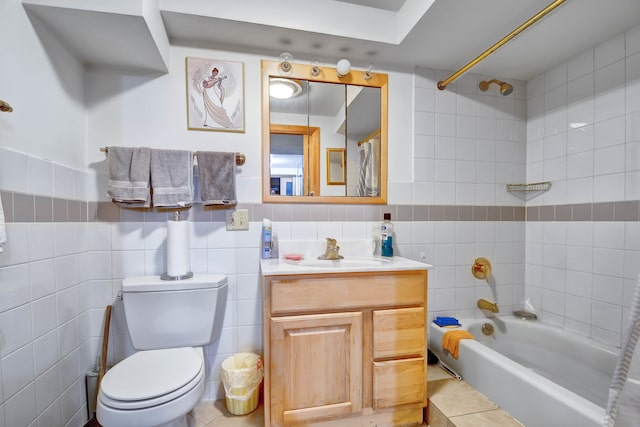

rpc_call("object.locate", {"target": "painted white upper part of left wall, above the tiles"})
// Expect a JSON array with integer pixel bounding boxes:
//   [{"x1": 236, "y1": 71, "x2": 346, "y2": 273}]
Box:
[{"x1": 0, "y1": 0, "x2": 86, "y2": 171}]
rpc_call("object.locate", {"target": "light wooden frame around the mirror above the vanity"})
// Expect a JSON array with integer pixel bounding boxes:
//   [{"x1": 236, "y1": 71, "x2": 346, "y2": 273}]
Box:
[{"x1": 261, "y1": 60, "x2": 389, "y2": 205}]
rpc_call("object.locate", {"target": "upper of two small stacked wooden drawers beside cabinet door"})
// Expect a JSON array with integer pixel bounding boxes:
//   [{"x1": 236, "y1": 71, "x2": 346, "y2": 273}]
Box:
[{"x1": 373, "y1": 307, "x2": 426, "y2": 359}]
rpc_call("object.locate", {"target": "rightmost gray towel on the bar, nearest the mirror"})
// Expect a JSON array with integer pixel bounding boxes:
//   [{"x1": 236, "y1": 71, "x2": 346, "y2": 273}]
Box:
[{"x1": 197, "y1": 151, "x2": 238, "y2": 206}]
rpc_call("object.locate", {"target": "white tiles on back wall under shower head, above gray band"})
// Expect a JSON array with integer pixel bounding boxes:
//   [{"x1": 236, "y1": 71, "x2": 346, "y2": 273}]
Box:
[{"x1": 416, "y1": 69, "x2": 527, "y2": 205}]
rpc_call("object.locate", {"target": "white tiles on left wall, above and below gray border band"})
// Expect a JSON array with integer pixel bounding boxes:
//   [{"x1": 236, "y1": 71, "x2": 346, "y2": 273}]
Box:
[{"x1": 0, "y1": 148, "x2": 102, "y2": 426}]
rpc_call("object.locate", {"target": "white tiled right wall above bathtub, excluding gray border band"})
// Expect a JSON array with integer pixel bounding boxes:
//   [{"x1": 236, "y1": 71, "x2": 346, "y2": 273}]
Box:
[{"x1": 526, "y1": 27, "x2": 640, "y2": 345}]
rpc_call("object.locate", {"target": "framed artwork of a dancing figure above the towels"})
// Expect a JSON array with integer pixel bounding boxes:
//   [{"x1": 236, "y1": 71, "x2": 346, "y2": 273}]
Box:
[{"x1": 186, "y1": 57, "x2": 244, "y2": 132}]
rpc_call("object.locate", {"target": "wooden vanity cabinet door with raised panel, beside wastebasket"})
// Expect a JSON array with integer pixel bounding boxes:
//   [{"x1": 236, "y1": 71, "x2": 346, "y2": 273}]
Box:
[{"x1": 270, "y1": 312, "x2": 362, "y2": 426}]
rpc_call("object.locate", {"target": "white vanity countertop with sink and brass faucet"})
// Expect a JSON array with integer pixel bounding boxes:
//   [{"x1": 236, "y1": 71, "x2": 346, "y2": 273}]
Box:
[{"x1": 260, "y1": 256, "x2": 433, "y2": 276}]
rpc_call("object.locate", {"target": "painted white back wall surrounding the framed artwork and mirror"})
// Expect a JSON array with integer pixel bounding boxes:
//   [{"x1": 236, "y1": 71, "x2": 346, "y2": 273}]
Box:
[{"x1": 86, "y1": 46, "x2": 413, "y2": 203}]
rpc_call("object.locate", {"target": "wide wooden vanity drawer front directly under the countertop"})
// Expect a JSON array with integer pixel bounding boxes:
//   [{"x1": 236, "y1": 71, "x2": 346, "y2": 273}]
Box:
[{"x1": 269, "y1": 271, "x2": 427, "y2": 314}]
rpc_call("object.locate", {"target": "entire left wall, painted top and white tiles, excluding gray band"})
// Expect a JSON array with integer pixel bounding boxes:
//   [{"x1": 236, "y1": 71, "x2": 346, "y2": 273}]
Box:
[{"x1": 0, "y1": 0, "x2": 93, "y2": 427}]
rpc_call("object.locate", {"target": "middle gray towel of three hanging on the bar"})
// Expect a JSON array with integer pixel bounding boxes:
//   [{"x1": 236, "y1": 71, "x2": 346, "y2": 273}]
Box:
[{"x1": 151, "y1": 149, "x2": 193, "y2": 207}]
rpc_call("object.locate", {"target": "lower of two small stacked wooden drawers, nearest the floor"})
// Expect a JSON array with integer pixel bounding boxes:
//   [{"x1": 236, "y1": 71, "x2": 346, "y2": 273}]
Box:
[{"x1": 373, "y1": 357, "x2": 427, "y2": 409}]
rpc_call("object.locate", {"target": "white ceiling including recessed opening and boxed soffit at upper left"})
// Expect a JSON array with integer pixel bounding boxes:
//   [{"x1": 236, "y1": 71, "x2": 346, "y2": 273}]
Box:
[{"x1": 23, "y1": 0, "x2": 640, "y2": 80}]
